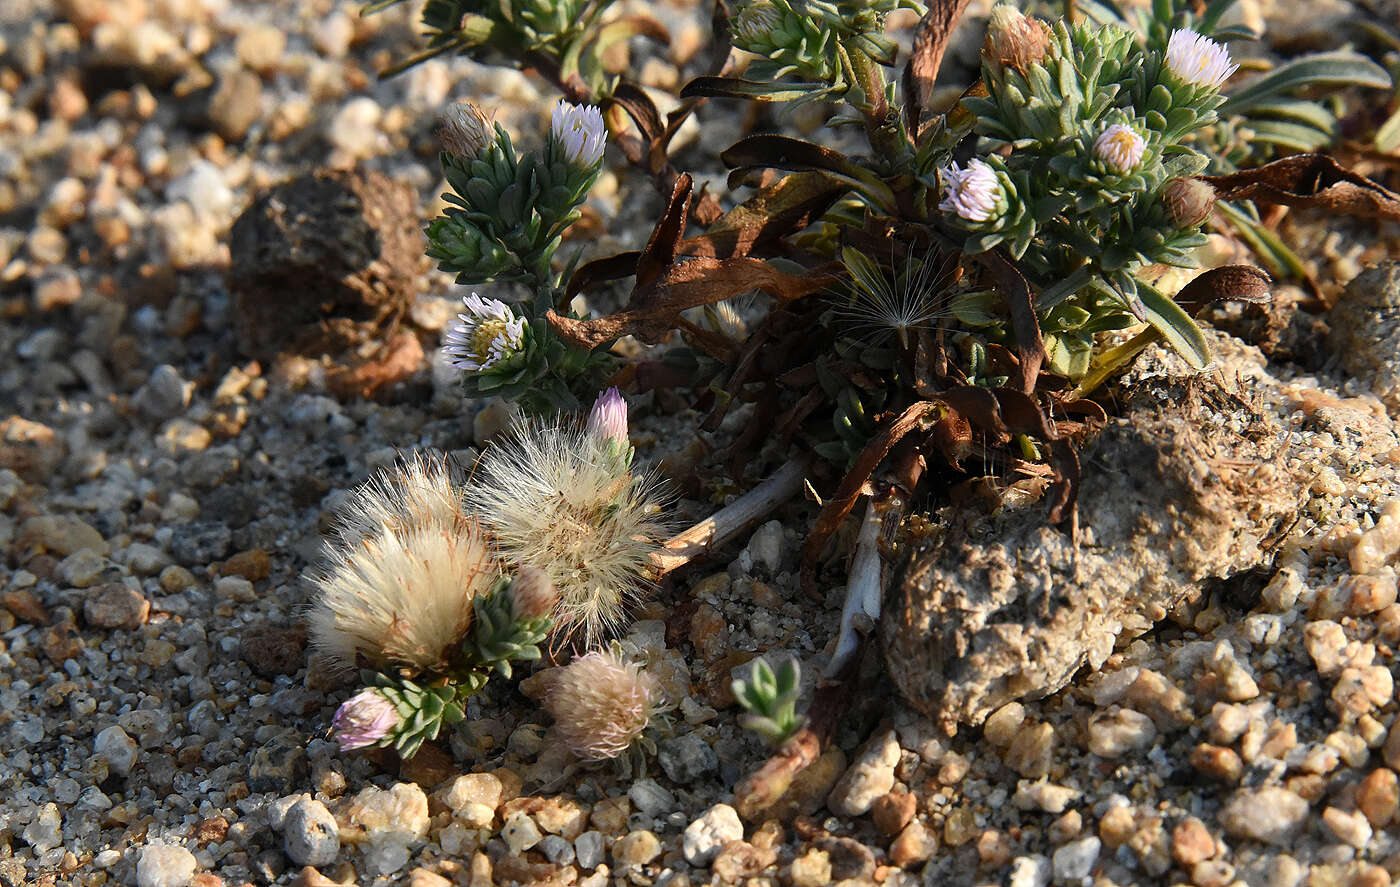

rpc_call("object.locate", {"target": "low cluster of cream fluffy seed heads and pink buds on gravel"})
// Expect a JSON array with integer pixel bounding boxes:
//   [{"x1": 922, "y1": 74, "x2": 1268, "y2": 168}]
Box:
[{"x1": 317, "y1": 388, "x2": 661, "y2": 757}]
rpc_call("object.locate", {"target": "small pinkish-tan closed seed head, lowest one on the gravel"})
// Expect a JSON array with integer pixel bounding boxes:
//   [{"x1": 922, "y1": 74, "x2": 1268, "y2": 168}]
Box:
[{"x1": 545, "y1": 651, "x2": 661, "y2": 761}]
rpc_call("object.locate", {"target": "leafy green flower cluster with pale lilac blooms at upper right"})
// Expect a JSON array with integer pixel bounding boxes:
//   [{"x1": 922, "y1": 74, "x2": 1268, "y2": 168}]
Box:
[{"x1": 946, "y1": 6, "x2": 1236, "y2": 378}]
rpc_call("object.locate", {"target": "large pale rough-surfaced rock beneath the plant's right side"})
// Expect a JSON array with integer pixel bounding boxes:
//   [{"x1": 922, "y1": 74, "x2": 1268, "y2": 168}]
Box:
[{"x1": 883, "y1": 334, "x2": 1306, "y2": 733}]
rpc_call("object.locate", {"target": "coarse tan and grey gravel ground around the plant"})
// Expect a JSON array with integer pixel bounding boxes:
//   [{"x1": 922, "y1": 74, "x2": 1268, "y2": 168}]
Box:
[{"x1": 0, "y1": 0, "x2": 1400, "y2": 887}]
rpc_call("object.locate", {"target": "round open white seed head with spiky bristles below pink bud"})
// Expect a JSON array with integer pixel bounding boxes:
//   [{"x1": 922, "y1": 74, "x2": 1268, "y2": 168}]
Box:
[{"x1": 466, "y1": 423, "x2": 666, "y2": 645}]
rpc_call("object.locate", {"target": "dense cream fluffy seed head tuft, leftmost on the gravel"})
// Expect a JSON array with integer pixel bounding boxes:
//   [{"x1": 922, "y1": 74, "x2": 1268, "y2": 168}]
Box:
[{"x1": 307, "y1": 456, "x2": 498, "y2": 669}]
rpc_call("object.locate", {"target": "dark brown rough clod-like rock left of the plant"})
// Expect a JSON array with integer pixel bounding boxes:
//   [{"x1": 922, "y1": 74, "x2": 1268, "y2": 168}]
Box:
[{"x1": 228, "y1": 171, "x2": 427, "y2": 360}]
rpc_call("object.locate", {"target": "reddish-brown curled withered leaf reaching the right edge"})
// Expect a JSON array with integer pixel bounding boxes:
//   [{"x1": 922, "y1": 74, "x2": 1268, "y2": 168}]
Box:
[{"x1": 1200, "y1": 154, "x2": 1400, "y2": 221}]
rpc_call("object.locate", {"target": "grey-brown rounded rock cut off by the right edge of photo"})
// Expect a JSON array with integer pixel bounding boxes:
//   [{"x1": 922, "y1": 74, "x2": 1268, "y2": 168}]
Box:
[{"x1": 1327, "y1": 262, "x2": 1400, "y2": 416}]
